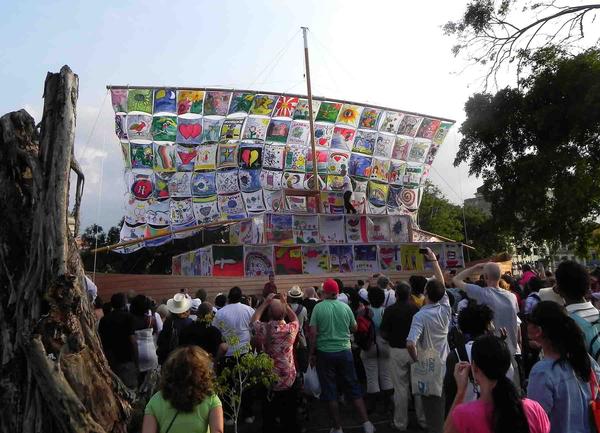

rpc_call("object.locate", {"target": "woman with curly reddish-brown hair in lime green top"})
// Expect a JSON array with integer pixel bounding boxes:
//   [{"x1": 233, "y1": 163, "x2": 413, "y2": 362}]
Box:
[{"x1": 142, "y1": 346, "x2": 223, "y2": 433}]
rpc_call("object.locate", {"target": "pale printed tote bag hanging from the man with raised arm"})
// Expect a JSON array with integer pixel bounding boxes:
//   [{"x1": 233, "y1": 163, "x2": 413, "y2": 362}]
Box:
[{"x1": 410, "y1": 335, "x2": 446, "y2": 397}]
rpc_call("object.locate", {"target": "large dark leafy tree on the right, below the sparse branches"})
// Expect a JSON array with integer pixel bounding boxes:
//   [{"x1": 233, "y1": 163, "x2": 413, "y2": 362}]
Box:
[{"x1": 454, "y1": 48, "x2": 600, "y2": 254}]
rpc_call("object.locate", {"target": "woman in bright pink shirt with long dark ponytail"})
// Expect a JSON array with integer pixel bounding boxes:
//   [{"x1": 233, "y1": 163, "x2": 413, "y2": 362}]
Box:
[{"x1": 444, "y1": 335, "x2": 550, "y2": 433}]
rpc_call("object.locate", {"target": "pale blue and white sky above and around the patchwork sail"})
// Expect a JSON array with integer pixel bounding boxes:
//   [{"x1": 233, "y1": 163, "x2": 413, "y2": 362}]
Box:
[{"x1": 0, "y1": 0, "x2": 482, "y2": 229}]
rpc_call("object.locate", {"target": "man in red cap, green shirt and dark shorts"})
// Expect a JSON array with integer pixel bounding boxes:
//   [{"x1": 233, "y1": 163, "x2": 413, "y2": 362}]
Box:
[{"x1": 310, "y1": 278, "x2": 375, "y2": 433}]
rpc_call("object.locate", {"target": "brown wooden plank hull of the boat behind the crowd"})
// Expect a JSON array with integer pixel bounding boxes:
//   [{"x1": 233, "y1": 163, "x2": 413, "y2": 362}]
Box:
[{"x1": 89, "y1": 271, "x2": 431, "y2": 302}]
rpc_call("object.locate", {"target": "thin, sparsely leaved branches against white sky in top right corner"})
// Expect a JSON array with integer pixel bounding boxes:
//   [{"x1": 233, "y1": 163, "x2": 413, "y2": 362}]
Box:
[{"x1": 444, "y1": 0, "x2": 600, "y2": 88}]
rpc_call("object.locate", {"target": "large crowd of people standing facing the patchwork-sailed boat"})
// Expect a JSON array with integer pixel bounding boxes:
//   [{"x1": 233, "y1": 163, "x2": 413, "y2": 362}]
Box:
[{"x1": 95, "y1": 249, "x2": 600, "y2": 433}]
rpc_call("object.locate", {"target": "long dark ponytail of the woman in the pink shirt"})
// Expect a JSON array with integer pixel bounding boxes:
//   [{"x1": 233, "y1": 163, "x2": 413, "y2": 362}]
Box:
[{"x1": 492, "y1": 376, "x2": 529, "y2": 433}]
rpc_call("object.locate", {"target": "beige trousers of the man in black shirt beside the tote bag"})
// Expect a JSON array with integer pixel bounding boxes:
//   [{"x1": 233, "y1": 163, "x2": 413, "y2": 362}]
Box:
[{"x1": 390, "y1": 347, "x2": 427, "y2": 430}]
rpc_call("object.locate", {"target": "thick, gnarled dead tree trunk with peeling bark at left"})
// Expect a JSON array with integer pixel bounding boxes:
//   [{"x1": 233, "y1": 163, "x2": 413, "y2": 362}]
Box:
[{"x1": 0, "y1": 66, "x2": 131, "y2": 433}]
